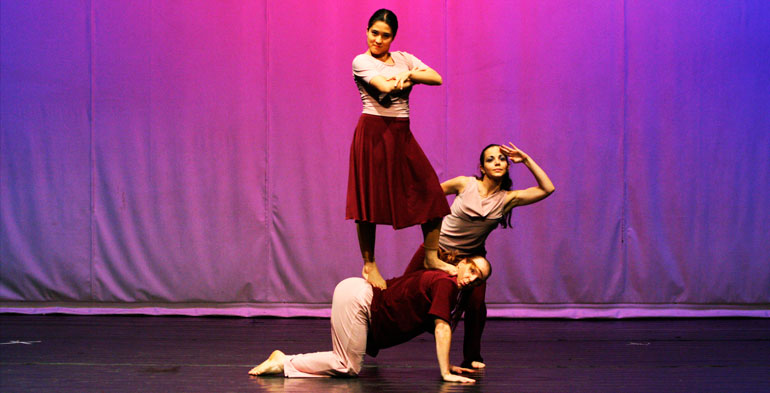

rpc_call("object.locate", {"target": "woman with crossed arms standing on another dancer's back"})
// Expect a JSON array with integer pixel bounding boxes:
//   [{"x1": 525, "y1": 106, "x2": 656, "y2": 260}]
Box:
[{"x1": 345, "y1": 9, "x2": 448, "y2": 289}]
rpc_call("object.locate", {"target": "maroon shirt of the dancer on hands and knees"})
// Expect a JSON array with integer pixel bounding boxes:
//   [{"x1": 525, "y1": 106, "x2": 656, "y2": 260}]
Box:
[{"x1": 366, "y1": 270, "x2": 459, "y2": 356}]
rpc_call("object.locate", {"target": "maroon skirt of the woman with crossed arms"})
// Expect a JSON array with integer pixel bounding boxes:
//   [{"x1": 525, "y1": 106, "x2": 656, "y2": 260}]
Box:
[{"x1": 345, "y1": 114, "x2": 449, "y2": 229}]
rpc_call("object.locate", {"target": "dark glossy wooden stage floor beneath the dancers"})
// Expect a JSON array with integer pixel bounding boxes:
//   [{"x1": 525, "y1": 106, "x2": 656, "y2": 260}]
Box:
[{"x1": 0, "y1": 314, "x2": 770, "y2": 392}]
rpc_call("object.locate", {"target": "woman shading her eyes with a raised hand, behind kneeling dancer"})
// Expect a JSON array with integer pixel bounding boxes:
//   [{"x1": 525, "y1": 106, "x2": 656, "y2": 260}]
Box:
[{"x1": 404, "y1": 143, "x2": 555, "y2": 368}]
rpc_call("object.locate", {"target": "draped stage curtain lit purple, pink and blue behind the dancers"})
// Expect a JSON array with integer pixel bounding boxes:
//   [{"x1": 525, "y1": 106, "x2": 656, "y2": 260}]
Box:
[{"x1": 0, "y1": 0, "x2": 770, "y2": 317}]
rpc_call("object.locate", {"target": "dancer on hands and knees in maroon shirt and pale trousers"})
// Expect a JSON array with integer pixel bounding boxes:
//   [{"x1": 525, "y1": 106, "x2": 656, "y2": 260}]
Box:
[{"x1": 249, "y1": 256, "x2": 492, "y2": 383}]
